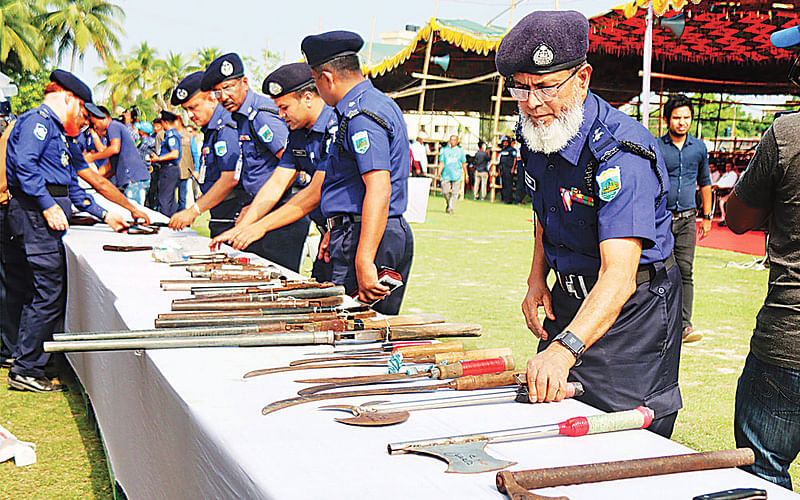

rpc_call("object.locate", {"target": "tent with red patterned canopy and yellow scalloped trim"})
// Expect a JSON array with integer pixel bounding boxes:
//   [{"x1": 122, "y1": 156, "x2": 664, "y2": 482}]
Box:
[{"x1": 367, "y1": 0, "x2": 800, "y2": 114}]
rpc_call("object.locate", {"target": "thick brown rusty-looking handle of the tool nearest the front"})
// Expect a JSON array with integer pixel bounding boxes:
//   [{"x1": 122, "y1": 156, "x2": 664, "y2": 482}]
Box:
[{"x1": 497, "y1": 448, "x2": 755, "y2": 493}]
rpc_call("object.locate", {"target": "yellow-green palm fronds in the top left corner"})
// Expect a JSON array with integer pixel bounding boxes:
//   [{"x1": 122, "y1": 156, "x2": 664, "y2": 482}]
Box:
[{"x1": 0, "y1": 0, "x2": 41, "y2": 72}]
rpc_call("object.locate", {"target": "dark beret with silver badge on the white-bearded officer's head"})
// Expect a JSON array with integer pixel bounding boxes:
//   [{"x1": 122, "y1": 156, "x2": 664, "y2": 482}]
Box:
[{"x1": 494, "y1": 10, "x2": 589, "y2": 77}]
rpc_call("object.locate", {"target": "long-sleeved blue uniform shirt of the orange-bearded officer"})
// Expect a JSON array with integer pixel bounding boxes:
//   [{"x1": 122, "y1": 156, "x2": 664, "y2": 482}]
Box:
[{"x1": 6, "y1": 104, "x2": 103, "y2": 217}]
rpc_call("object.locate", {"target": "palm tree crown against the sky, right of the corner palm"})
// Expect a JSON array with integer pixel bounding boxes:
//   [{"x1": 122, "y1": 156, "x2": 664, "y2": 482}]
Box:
[{"x1": 41, "y1": 0, "x2": 125, "y2": 71}]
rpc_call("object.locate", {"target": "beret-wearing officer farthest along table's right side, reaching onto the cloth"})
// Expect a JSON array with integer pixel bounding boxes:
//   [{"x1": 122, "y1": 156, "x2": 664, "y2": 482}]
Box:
[{"x1": 169, "y1": 71, "x2": 242, "y2": 238}]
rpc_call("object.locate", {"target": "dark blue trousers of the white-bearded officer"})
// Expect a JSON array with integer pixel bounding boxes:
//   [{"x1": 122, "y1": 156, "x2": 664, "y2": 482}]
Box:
[{"x1": 539, "y1": 262, "x2": 683, "y2": 438}]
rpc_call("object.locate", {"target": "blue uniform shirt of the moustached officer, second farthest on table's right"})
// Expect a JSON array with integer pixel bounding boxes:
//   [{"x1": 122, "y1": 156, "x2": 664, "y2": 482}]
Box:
[{"x1": 232, "y1": 90, "x2": 289, "y2": 196}]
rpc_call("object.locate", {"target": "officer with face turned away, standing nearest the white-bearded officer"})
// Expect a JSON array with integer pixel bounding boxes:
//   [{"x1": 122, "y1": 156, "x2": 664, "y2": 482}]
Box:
[{"x1": 216, "y1": 31, "x2": 414, "y2": 314}]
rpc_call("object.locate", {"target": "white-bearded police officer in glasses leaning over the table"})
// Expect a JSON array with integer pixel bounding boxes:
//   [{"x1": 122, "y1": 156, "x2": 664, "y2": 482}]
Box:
[{"x1": 496, "y1": 11, "x2": 682, "y2": 437}]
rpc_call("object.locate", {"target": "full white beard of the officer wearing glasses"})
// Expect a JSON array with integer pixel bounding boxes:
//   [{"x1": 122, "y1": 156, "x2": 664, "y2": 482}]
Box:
[{"x1": 519, "y1": 93, "x2": 583, "y2": 154}]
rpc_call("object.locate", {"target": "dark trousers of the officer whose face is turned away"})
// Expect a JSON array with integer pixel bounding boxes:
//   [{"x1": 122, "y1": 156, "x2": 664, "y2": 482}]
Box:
[{"x1": 330, "y1": 217, "x2": 414, "y2": 314}]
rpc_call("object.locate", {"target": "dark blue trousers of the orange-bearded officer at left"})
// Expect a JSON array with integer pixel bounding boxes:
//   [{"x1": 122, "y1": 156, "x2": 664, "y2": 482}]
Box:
[{"x1": 4, "y1": 196, "x2": 70, "y2": 377}]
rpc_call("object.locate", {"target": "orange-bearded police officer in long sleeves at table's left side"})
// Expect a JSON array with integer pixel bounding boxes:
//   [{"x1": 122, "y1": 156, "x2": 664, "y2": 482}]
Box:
[{"x1": 2, "y1": 70, "x2": 126, "y2": 392}]
